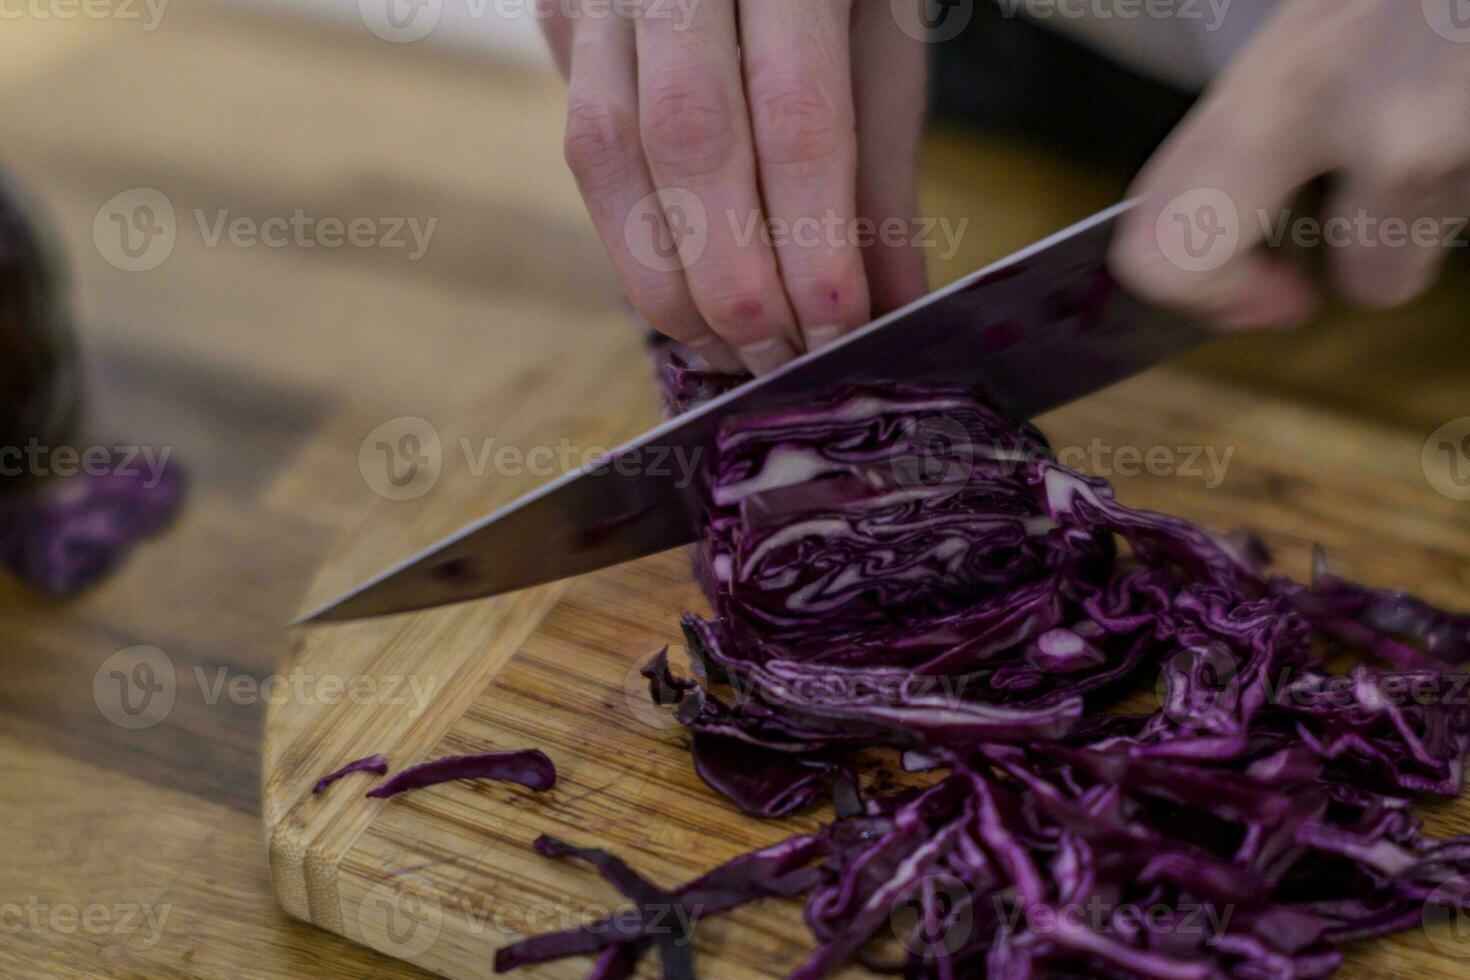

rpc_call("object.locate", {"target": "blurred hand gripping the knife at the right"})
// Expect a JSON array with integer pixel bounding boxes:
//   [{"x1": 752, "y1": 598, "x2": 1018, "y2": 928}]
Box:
[{"x1": 1111, "y1": 0, "x2": 1470, "y2": 329}]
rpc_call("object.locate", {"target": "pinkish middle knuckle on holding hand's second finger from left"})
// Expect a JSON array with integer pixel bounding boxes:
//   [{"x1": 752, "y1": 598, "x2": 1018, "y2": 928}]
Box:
[{"x1": 642, "y1": 68, "x2": 738, "y2": 176}]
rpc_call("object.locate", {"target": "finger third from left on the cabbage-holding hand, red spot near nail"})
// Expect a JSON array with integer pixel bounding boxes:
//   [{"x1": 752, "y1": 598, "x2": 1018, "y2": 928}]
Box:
[{"x1": 739, "y1": 0, "x2": 872, "y2": 350}]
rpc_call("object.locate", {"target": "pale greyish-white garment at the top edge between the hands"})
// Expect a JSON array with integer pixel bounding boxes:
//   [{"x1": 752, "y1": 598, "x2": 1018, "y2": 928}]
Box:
[{"x1": 995, "y1": 0, "x2": 1276, "y2": 90}]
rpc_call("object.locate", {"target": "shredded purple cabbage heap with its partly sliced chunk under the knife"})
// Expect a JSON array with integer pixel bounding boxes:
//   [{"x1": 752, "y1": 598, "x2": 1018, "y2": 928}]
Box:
[{"x1": 497, "y1": 354, "x2": 1470, "y2": 980}]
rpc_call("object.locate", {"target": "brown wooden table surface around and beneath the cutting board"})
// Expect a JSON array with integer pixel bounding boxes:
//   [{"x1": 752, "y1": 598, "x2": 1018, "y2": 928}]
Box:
[{"x1": 0, "y1": 3, "x2": 1470, "y2": 977}]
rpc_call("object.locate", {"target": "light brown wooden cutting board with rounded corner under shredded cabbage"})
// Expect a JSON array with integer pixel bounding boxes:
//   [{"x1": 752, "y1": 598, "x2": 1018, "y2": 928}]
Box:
[{"x1": 263, "y1": 354, "x2": 1470, "y2": 979}]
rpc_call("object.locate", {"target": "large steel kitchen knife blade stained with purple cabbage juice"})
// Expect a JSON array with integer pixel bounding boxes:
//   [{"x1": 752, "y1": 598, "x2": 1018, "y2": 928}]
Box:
[{"x1": 297, "y1": 201, "x2": 1210, "y2": 623}]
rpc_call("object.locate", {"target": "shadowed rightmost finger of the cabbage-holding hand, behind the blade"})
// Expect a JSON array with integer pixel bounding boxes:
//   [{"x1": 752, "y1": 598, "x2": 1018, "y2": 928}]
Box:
[{"x1": 853, "y1": 1, "x2": 929, "y2": 316}]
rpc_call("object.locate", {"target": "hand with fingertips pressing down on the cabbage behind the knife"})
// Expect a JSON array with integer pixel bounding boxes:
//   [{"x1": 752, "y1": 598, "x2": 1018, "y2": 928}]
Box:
[{"x1": 542, "y1": 0, "x2": 928, "y2": 373}]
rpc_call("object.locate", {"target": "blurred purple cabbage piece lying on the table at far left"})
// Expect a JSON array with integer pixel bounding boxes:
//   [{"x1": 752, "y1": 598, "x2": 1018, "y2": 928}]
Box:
[{"x1": 0, "y1": 463, "x2": 184, "y2": 595}]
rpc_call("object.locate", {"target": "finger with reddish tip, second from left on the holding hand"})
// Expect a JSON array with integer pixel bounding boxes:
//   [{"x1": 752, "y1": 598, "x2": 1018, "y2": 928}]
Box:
[{"x1": 638, "y1": 0, "x2": 797, "y2": 375}]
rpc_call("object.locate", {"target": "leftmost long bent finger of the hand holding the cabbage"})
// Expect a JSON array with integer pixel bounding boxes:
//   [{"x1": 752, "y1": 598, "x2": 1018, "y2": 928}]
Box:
[{"x1": 566, "y1": 18, "x2": 741, "y2": 372}]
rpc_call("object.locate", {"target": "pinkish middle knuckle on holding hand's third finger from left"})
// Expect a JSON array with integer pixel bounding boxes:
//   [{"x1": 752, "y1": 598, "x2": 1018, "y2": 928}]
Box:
[{"x1": 750, "y1": 71, "x2": 854, "y2": 175}]
